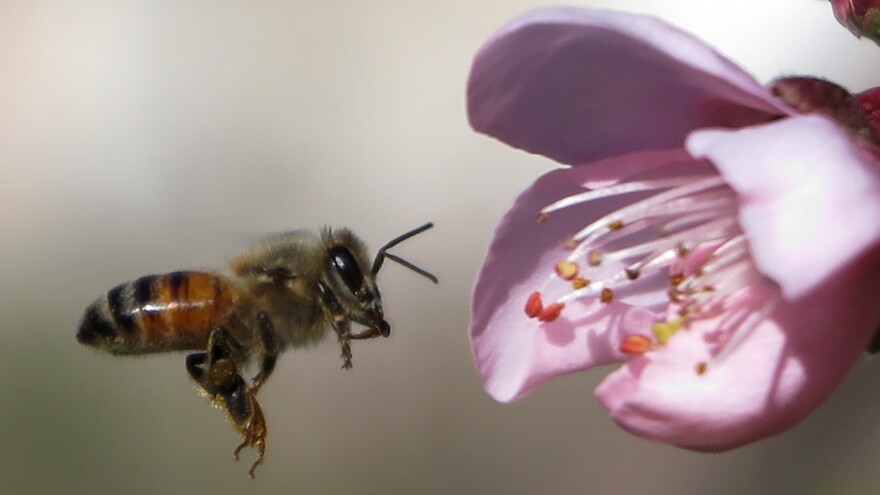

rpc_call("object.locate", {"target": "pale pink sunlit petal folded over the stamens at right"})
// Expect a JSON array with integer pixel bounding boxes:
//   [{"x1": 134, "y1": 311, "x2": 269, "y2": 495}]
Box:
[{"x1": 687, "y1": 116, "x2": 880, "y2": 299}]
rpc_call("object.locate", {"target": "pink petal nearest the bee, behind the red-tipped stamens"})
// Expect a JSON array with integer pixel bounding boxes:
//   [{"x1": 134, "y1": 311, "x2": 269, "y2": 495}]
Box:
[{"x1": 471, "y1": 167, "x2": 656, "y2": 402}]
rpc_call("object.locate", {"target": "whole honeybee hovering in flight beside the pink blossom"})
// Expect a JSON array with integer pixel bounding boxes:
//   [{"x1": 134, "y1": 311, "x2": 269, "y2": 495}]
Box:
[{"x1": 76, "y1": 223, "x2": 437, "y2": 478}]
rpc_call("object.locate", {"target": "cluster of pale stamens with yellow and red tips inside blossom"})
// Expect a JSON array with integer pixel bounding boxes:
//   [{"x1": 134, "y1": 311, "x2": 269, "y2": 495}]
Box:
[{"x1": 525, "y1": 171, "x2": 775, "y2": 374}]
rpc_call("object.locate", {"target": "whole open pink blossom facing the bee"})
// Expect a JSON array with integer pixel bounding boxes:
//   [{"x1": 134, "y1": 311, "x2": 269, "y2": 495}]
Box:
[{"x1": 468, "y1": 5, "x2": 880, "y2": 450}]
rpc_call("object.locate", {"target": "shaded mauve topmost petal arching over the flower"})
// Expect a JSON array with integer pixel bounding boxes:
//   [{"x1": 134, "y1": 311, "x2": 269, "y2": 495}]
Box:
[{"x1": 468, "y1": 8, "x2": 788, "y2": 164}]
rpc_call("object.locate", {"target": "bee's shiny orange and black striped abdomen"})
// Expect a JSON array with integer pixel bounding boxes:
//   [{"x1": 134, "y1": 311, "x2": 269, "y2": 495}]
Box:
[{"x1": 76, "y1": 271, "x2": 234, "y2": 354}]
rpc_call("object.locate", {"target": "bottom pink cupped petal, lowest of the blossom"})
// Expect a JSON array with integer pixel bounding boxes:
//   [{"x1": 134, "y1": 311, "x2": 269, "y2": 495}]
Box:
[{"x1": 595, "y1": 252, "x2": 880, "y2": 451}]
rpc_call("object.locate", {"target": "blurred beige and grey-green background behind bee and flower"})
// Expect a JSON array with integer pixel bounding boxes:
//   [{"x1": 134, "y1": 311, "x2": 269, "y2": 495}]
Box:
[{"x1": 0, "y1": 0, "x2": 880, "y2": 495}]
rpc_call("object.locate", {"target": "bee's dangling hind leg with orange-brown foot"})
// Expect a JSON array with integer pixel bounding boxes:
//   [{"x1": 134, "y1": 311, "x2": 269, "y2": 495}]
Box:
[{"x1": 186, "y1": 327, "x2": 267, "y2": 478}]
